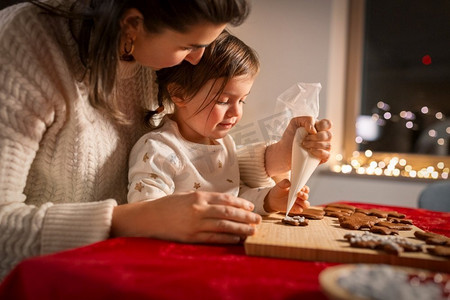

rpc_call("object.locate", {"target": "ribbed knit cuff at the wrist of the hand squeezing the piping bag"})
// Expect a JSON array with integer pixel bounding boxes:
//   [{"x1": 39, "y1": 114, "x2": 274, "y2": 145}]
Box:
[{"x1": 237, "y1": 143, "x2": 274, "y2": 188}]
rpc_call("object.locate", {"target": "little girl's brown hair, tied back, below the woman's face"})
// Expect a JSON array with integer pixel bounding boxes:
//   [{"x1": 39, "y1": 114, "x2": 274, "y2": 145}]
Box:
[{"x1": 146, "y1": 30, "x2": 259, "y2": 128}]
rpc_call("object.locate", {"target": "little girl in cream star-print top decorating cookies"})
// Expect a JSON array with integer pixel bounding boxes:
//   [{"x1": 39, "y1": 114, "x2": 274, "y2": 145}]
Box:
[{"x1": 128, "y1": 31, "x2": 308, "y2": 215}]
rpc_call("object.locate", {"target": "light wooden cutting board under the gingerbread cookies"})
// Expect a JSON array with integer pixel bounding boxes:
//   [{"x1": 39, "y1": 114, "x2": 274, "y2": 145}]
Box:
[{"x1": 244, "y1": 214, "x2": 450, "y2": 272}]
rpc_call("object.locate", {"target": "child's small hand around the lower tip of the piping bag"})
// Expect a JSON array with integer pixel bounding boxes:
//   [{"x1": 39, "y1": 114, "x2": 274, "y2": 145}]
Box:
[{"x1": 264, "y1": 179, "x2": 310, "y2": 213}]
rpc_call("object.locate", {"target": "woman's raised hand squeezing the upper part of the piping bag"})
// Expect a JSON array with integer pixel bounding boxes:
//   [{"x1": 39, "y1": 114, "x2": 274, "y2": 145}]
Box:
[{"x1": 265, "y1": 116, "x2": 332, "y2": 177}]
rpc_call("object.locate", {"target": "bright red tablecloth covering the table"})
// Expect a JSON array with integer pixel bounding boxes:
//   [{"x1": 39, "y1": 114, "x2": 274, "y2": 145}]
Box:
[{"x1": 0, "y1": 202, "x2": 450, "y2": 300}]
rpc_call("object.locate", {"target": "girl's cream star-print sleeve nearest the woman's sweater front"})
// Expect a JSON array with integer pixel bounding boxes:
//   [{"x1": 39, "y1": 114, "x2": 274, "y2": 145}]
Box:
[{"x1": 128, "y1": 135, "x2": 180, "y2": 203}]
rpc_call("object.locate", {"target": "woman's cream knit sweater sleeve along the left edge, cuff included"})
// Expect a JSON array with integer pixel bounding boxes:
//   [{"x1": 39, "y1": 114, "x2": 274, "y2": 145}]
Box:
[{"x1": 0, "y1": 5, "x2": 116, "y2": 278}]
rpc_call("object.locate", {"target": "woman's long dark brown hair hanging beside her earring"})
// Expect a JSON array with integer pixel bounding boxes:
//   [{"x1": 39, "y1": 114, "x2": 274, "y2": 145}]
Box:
[{"x1": 31, "y1": 0, "x2": 250, "y2": 124}]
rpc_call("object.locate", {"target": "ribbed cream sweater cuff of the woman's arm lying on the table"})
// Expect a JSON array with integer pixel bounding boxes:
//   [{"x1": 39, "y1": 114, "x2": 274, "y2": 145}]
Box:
[{"x1": 41, "y1": 199, "x2": 117, "y2": 254}]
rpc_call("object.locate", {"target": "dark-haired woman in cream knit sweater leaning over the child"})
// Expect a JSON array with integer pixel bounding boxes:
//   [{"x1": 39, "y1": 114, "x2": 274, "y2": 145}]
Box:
[{"x1": 0, "y1": 0, "x2": 331, "y2": 277}]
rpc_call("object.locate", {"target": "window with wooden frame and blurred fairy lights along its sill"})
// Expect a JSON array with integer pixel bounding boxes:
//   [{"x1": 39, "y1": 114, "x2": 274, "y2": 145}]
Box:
[{"x1": 339, "y1": 0, "x2": 450, "y2": 179}]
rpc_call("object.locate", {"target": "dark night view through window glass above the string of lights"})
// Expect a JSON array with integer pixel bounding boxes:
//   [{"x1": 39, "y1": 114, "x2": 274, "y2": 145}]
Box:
[{"x1": 360, "y1": 0, "x2": 450, "y2": 155}]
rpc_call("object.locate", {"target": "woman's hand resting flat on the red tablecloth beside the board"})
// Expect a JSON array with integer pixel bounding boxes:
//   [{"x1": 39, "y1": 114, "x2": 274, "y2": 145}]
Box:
[{"x1": 111, "y1": 192, "x2": 261, "y2": 243}]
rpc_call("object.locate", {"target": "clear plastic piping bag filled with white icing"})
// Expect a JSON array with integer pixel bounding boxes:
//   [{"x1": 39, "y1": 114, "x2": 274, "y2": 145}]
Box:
[{"x1": 277, "y1": 83, "x2": 322, "y2": 216}]
